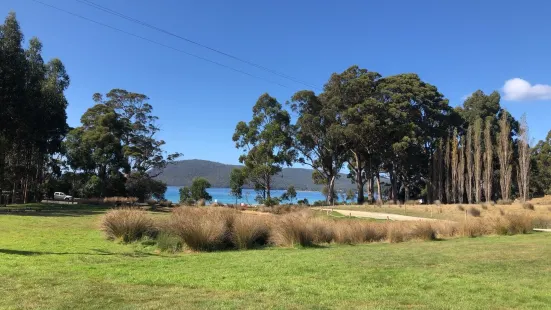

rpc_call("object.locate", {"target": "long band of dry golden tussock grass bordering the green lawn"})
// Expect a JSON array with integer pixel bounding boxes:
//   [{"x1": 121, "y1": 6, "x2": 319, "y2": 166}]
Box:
[{"x1": 104, "y1": 203, "x2": 551, "y2": 251}]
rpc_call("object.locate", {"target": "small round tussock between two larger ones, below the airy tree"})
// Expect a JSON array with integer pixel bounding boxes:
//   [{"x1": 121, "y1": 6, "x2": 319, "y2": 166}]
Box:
[{"x1": 231, "y1": 214, "x2": 270, "y2": 249}]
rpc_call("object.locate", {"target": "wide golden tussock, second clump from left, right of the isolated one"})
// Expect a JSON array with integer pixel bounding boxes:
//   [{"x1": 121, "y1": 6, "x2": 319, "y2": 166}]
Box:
[{"x1": 169, "y1": 207, "x2": 236, "y2": 251}]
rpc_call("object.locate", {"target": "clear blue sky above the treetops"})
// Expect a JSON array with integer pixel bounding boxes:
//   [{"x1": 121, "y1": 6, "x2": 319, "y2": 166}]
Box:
[{"x1": 0, "y1": 0, "x2": 551, "y2": 163}]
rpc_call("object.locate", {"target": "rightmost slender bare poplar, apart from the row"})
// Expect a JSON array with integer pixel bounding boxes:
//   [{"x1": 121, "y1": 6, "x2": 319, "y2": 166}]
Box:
[{"x1": 518, "y1": 114, "x2": 530, "y2": 201}]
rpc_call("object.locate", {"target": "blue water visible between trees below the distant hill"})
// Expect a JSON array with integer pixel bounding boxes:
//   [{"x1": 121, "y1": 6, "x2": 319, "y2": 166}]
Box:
[{"x1": 165, "y1": 186, "x2": 325, "y2": 204}]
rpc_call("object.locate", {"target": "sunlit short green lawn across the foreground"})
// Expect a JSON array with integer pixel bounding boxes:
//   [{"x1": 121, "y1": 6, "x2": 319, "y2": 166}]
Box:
[{"x1": 0, "y1": 206, "x2": 551, "y2": 309}]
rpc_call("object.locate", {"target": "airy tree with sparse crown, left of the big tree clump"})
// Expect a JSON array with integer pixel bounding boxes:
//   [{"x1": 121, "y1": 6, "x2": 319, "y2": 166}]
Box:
[{"x1": 233, "y1": 94, "x2": 295, "y2": 204}]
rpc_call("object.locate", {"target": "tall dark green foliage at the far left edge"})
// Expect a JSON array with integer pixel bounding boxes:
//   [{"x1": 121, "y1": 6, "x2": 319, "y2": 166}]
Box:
[{"x1": 0, "y1": 12, "x2": 69, "y2": 201}]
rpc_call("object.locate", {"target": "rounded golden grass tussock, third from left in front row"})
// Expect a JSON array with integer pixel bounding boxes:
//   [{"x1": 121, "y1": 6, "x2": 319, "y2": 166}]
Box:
[{"x1": 271, "y1": 214, "x2": 315, "y2": 247}]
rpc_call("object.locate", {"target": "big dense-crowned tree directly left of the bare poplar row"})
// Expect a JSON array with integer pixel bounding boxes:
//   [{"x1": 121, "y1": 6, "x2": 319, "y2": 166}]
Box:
[{"x1": 378, "y1": 74, "x2": 455, "y2": 200}]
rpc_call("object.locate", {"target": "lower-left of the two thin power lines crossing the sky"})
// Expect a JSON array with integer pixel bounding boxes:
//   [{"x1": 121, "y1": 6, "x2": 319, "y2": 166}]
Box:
[{"x1": 32, "y1": 0, "x2": 298, "y2": 89}]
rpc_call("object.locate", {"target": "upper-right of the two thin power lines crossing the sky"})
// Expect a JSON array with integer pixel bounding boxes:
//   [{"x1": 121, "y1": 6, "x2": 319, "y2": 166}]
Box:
[{"x1": 75, "y1": 0, "x2": 316, "y2": 89}]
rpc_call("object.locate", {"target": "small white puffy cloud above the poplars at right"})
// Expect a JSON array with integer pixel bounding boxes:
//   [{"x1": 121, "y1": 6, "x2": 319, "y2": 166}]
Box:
[{"x1": 503, "y1": 78, "x2": 551, "y2": 101}]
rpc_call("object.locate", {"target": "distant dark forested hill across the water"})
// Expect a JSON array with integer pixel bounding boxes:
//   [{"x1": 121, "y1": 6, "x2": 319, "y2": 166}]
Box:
[{"x1": 152, "y1": 159, "x2": 355, "y2": 191}]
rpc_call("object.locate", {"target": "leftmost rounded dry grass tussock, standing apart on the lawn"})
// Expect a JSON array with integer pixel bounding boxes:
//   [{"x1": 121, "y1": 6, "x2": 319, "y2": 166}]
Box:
[{"x1": 101, "y1": 208, "x2": 155, "y2": 242}]
